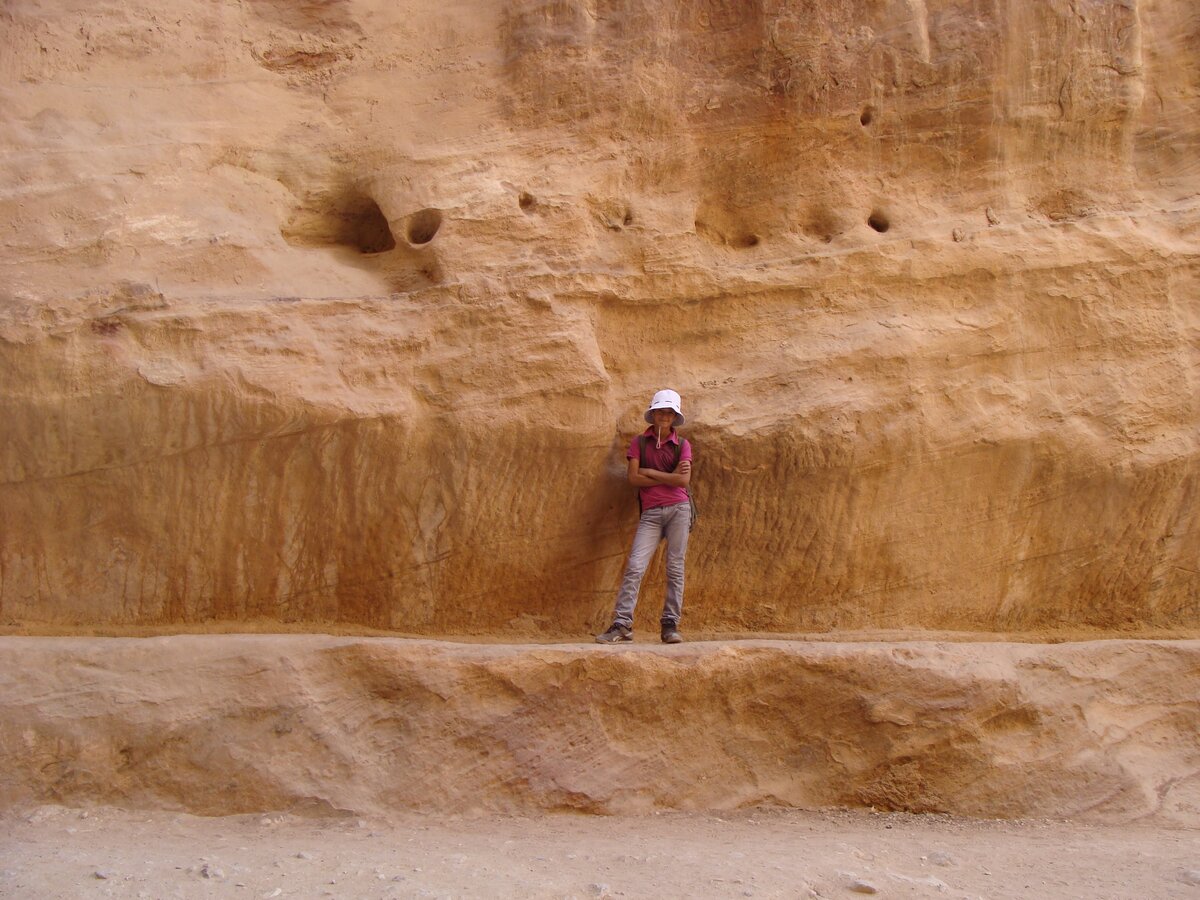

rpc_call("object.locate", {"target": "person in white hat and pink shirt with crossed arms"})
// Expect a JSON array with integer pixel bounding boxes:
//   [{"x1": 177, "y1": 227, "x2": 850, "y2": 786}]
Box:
[{"x1": 596, "y1": 390, "x2": 691, "y2": 643}]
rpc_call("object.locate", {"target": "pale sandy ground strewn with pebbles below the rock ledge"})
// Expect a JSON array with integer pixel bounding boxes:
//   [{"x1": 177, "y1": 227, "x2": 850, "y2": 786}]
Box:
[{"x1": 0, "y1": 806, "x2": 1200, "y2": 900}]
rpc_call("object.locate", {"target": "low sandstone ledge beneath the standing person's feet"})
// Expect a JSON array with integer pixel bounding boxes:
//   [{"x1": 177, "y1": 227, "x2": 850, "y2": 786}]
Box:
[{"x1": 0, "y1": 635, "x2": 1200, "y2": 828}]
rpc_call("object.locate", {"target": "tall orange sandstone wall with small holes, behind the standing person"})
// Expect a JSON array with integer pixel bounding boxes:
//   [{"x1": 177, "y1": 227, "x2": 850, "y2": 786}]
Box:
[{"x1": 0, "y1": 0, "x2": 1200, "y2": 633}]
